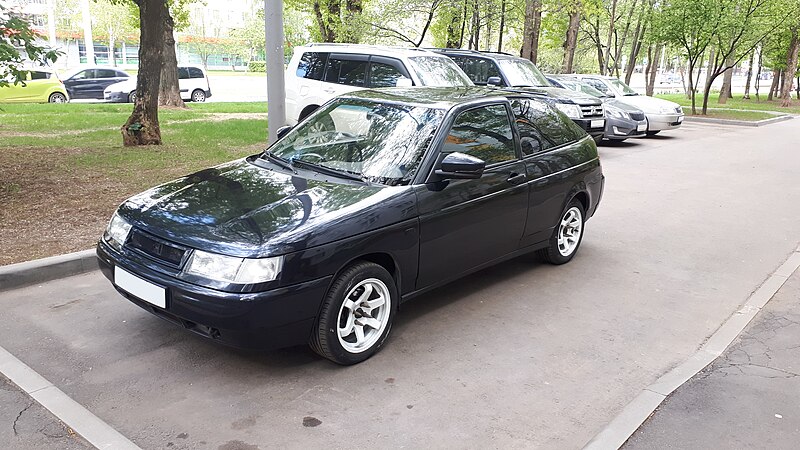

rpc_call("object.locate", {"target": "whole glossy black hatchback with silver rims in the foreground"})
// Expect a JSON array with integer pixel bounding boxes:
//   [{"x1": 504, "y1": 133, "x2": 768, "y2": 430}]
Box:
[{"x1": 97, "y1": 87, "x2": 604, "y2": 364}]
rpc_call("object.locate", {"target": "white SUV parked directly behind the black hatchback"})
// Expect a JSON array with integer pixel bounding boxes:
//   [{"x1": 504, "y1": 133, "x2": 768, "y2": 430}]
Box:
[{"x1": 286, "y1": 44, "x2": 472, "y2": 125}]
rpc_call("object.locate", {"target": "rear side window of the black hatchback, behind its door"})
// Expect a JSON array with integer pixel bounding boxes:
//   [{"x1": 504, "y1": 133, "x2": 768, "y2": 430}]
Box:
[{"x1": 511, "y1": 99, "x2": 582, "y2": 156}]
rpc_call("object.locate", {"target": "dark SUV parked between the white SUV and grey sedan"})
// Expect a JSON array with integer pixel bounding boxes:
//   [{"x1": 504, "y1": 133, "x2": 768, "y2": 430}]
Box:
[{"x1": 433, "y1": 49, "x2": 605, "y2": 141}]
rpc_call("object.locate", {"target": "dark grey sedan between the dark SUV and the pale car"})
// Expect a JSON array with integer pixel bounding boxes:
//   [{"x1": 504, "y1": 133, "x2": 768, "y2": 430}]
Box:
[{"x1": 547, "y1": 75, "x2": 647, "y2": 142}]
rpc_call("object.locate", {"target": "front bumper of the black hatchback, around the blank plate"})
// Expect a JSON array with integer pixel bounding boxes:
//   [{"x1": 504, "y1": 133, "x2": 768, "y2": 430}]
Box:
[{"x1": 97, "y1": 241, "x2": 331, "y2": 350}]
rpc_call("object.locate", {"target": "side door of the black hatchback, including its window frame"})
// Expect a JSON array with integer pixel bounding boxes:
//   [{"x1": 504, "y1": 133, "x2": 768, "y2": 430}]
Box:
[{"x1": 417, "y1": 103, "x2": 528, "y2": 289}]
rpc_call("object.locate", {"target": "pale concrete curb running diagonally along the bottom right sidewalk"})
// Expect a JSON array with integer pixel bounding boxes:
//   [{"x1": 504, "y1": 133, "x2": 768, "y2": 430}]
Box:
[{"x1": 584, "y1": 247, "x2": 800, "y2": 450}]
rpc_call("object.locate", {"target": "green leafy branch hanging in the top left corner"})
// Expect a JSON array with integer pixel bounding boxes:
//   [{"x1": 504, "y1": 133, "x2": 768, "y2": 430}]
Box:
[{"x1": 0, "y1": 5, "x2": 61, "y2": 87}]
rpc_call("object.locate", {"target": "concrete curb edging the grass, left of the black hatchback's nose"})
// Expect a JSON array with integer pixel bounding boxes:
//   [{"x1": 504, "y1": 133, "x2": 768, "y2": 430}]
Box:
[{"x1": 0, "y1": 249, "x2": 97, "y2": 292}]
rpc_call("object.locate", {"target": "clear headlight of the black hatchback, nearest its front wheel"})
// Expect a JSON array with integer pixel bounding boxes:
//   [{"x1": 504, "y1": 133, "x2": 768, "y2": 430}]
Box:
[{"x1": 184, "y1": 250, "x2": 283, "y2": 284}]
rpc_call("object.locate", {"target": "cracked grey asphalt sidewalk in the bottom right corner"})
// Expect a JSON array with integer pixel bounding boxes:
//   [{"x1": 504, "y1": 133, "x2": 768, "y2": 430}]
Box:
[{"x1": 623, "y1": 270, "x2": 800, "y2": 450}]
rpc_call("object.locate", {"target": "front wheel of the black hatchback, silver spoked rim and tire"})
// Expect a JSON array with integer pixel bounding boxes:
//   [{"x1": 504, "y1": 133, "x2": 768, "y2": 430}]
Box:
[{"x1": 309, "y1": 261, "x2": 399, "y2": 366}]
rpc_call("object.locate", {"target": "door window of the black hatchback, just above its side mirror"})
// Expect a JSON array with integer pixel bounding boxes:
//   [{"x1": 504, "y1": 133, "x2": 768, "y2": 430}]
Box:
[{"x1": 442, "y1": 105, "x2": 517, "y2": 165}]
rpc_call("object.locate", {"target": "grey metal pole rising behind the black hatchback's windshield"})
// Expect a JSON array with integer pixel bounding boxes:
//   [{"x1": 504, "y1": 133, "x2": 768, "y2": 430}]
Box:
[{"x1": 264, "y1": 0, "x2": 286, "y2": 144}]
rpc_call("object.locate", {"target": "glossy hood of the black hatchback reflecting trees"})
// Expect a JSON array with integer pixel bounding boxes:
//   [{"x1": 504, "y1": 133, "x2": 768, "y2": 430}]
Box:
[{"x1": 119, "y1": 159, "x2": 416, "y2": 257}]
